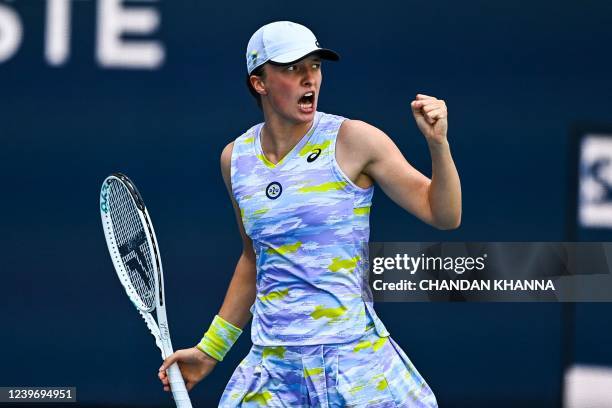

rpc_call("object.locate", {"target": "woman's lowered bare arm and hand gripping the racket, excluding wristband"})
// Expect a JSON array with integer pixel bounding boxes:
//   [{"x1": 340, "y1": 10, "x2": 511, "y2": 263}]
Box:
[{"x1": 158, "y1": 143, "x2": 257, "y2": 391}]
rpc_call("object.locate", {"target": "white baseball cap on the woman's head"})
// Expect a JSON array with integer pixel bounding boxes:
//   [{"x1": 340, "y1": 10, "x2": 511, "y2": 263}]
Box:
[{"x1": 246, "y1": 21, "x2": 340, "y2": 74}]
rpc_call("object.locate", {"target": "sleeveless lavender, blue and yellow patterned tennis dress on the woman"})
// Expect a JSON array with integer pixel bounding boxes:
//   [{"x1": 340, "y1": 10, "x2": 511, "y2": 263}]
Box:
[{"x1": 219, "y1": 112, "x2": 437, "y2": 408}]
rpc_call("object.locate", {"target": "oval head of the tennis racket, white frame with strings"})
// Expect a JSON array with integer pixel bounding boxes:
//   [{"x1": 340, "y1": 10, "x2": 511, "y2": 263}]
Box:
[{"x1": 100, "y1": 173, "x2": 163, "y2": 312}]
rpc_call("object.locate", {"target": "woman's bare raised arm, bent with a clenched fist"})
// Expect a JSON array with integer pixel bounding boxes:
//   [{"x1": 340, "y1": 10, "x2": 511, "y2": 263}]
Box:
[{"x1": 337, "y1": 94, "x2": 461, "y2": 229}]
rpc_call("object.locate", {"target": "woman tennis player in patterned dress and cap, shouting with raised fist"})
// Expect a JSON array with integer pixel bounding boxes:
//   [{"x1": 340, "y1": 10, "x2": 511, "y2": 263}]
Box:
[{"x1": 159, "y1": 21, "x2": 461, "y2": 407}]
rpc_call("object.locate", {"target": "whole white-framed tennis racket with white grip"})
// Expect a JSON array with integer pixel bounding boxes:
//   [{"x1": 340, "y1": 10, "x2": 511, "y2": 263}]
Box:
[{"x1": 100, "y1": 173, "x2": 191, "y2": 408}]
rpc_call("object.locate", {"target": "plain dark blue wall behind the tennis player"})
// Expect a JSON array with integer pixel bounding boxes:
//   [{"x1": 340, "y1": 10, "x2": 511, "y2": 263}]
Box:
[{"x1": 0, "y1": 0, "x2": 612, "y2": 407}]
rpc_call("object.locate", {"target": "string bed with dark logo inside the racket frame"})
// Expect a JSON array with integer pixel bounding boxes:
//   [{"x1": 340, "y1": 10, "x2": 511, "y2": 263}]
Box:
[{"x1": 109, "y1": 181, "x2": 155, "y2": 308}]
